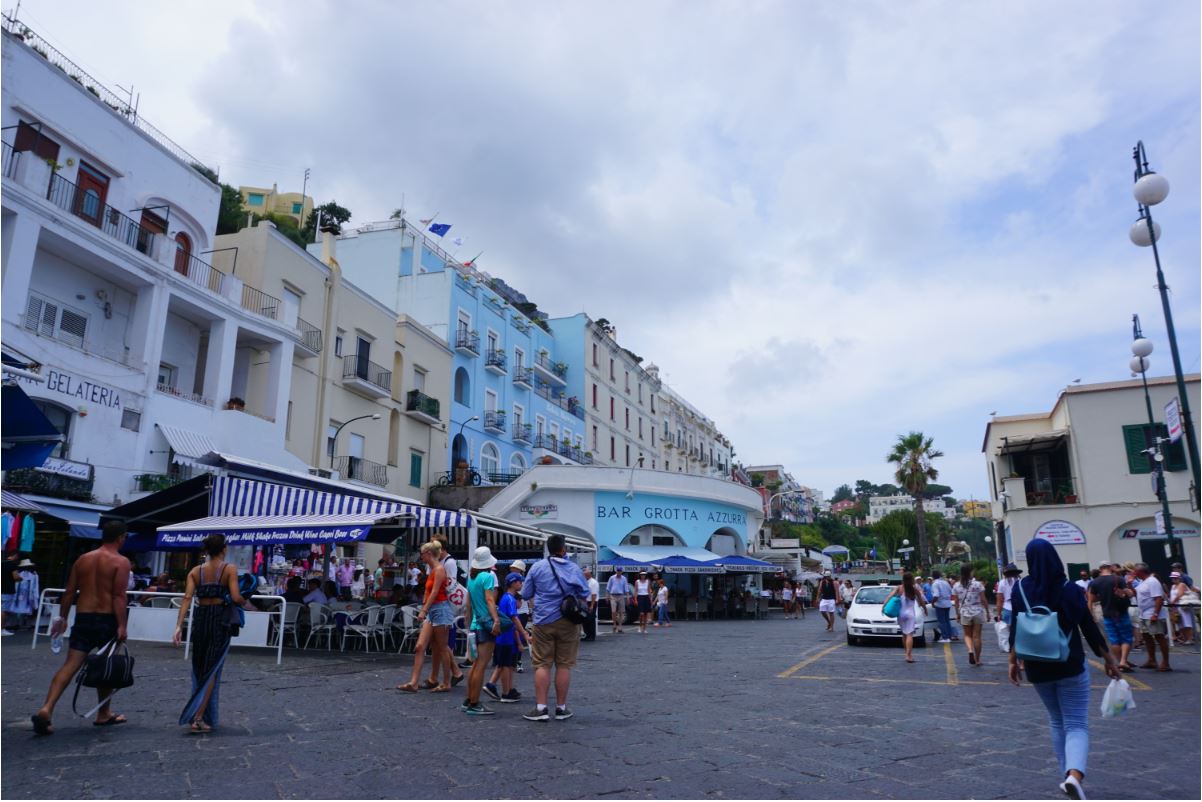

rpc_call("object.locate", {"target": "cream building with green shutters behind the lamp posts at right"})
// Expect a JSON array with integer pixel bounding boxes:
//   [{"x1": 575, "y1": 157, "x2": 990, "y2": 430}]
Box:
[{"x1": 982, "y1": 374, "x2": 1200, "y2": 577}]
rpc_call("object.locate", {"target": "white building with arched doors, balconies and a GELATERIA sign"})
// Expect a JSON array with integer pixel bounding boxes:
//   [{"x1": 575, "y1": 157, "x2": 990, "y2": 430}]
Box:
[{"x1": 0, "y1": 20, "x2": 305, "y2": 538}]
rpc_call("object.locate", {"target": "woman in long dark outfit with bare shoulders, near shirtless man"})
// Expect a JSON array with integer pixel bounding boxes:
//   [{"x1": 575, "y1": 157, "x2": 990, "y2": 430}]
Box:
[{"x1": 171, "y1": 534, "x2": 255, "y2": 735}]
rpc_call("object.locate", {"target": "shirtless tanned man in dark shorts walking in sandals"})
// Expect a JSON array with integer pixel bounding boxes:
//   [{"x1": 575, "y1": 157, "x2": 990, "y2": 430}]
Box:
[{"x1": 30, "y1": 521, "x2": 130, "y2": 735}]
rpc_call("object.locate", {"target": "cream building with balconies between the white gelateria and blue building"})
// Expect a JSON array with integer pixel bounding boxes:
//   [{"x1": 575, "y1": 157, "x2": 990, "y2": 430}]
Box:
[{"x1": 215, "y1": 221, "x2": 451, "y2": 501}]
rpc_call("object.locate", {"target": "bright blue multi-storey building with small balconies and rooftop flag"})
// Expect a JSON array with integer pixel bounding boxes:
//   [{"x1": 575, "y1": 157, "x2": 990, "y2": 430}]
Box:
[{"x1": 338, "y1": 220, "x2": 593, "y2": 483}]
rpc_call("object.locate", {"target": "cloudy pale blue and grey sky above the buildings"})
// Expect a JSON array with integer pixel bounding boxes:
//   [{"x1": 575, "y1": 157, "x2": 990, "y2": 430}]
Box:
[{"x1": 14, "y1": 0, "x2": 1200, "y2": 498}]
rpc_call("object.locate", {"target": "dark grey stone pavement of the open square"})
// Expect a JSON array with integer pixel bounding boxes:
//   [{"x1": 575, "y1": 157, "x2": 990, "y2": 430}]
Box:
[{"x1": 0, "y1": 613, "x2": 1200, "y2": 800}]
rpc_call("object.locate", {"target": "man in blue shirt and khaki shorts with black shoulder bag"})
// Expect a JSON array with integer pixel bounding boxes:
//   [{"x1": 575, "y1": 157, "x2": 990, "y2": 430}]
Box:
[{"x1": 522, "y1": 535, "x2": 589, "y2": 721}]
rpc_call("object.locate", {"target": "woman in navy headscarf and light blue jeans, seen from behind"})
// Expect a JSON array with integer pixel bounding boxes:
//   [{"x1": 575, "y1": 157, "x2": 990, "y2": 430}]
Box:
[{"x1": 1010, "y1": 537, "x2": 1121, "y2": 800}]
